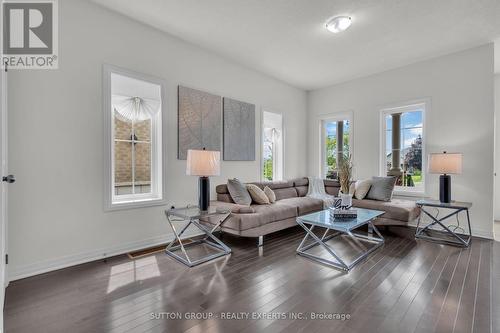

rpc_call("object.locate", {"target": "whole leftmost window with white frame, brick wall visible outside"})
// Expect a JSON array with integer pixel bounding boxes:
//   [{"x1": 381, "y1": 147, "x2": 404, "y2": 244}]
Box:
[{"x1": 106, "y1": 68, "x2": 164, "y2": 208}]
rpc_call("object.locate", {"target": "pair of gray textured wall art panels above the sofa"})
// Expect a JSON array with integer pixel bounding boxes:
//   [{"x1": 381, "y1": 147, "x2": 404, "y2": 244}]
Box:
[{"x1": 177, "y1": 86, "x2": 255, "y2": 161}]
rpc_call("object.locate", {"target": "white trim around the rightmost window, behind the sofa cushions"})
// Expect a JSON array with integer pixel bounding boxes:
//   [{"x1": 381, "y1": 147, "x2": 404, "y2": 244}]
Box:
[{"x1": 379, "y1": 98, "x2": 431, "y2": 197}]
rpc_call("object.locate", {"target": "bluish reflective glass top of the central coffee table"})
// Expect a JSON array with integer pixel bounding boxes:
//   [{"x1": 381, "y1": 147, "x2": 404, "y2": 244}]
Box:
[{"x1": 299, "y1": 208, "x2": 384, "y2": 232}]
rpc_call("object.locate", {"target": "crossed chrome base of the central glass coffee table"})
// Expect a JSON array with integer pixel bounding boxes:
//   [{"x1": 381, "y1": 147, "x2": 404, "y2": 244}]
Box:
[{"x1": 297, "y1": 219, "x2": 384, "y2": 272}]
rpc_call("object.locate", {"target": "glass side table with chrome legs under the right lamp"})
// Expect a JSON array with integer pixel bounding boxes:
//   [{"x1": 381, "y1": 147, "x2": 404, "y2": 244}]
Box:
[{"x1": 415, "y1": 199, "x2": 472, "y2": 247}]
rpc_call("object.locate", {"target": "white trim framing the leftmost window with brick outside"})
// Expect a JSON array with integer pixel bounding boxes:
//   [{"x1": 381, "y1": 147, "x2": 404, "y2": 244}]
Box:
[{"x1": 103, "y1": 64, "x2": 167, "y2": 211}]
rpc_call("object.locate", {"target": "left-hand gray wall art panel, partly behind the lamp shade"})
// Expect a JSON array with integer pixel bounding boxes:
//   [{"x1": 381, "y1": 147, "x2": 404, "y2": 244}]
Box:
[{"x1": 177, "y1": 86, "x2": 222, "y2": 160}]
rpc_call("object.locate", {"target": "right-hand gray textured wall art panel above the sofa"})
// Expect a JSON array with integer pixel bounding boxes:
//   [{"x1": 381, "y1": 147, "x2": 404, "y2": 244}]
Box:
[{"x1": 223, "y1": 97, "x2": 255, "y2": 161}]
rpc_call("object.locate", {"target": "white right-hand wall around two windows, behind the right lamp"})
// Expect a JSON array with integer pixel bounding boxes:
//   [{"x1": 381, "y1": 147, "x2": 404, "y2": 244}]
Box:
[{"x1": 308, "y1": 44, "x2": 494, "y2": 238}]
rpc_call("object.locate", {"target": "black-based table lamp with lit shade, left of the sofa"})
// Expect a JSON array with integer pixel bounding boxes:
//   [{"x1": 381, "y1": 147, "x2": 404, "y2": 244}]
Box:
[{"x1": 186, "y1": 148, "x2": 220, "y2": 211}]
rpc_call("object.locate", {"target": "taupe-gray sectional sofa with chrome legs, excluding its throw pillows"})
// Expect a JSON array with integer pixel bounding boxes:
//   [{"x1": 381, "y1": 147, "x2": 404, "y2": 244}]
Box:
[{"x1": 203, "y1": 178, "x2": 420, "y2": 237}]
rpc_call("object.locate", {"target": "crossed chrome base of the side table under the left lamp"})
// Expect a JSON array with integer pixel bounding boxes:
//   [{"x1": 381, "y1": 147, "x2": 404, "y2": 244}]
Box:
[{"x1": 165, "y1": 211, "x2": 231, "y2": 267}]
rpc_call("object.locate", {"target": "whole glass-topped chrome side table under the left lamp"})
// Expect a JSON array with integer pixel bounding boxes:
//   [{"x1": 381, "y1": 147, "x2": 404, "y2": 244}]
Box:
[{"x1": 165, "y1": 206, "x2": 231, "y2": 267}]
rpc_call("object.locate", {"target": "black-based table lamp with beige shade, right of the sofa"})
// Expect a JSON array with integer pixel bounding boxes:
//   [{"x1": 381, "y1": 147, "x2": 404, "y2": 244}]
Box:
[{"x1": 429, "y1": 152, "x2": 462, "y2": 203}]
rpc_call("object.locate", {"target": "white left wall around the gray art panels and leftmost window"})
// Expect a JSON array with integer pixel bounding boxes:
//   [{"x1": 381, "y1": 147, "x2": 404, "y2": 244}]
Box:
[{"x1": 9, "y1": 0, "x2": 306, "y2": 278}]
